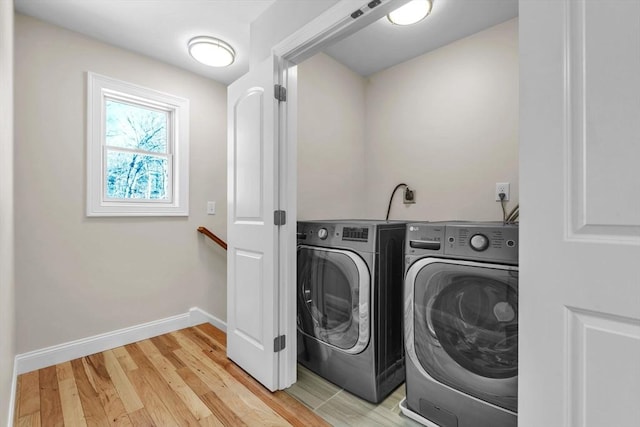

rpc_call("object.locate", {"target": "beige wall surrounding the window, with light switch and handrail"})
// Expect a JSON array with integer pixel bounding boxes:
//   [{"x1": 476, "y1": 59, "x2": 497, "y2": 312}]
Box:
[{"x1": 15, "y1": 15, "x2": 227, "y2": 353}]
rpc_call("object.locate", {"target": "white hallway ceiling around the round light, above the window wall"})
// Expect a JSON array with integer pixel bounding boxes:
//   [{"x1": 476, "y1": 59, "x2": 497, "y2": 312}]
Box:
[{"x1": 14, "y1": 0, "x2": 275, "y2": 84}]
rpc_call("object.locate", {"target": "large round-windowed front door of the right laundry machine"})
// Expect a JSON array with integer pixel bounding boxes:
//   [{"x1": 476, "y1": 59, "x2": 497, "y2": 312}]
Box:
[{"x1": 405, "y1": 258, "x2": 518, "y2": 413}]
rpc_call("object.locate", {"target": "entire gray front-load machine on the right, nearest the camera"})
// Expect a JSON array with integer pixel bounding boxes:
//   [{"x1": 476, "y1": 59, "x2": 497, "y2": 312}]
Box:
[{"x1": 404, "y1": 222, "x2": 518, "y2": 427}]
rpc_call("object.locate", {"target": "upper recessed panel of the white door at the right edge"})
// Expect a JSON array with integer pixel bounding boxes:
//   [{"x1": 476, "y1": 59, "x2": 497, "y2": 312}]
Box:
[{"x1": 567, "y1": 0, "x2": 640, "y2": 239}]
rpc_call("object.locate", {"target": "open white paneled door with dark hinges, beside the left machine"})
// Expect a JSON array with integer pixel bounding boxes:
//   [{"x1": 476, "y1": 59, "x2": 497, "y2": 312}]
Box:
[{"x1": 227, "y1": 58, "x2": 279, "y2": 391}]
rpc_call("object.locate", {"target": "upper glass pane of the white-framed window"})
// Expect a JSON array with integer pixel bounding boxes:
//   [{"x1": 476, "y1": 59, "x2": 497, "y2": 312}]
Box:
[{"x1": 105, "y1": 99, "x2": 168, "y2": 153}]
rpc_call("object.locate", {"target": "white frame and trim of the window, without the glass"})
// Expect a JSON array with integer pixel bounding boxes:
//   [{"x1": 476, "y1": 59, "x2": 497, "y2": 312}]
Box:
[{"x1": 87, "y1": 72, "x2": 189, "y2": 216}]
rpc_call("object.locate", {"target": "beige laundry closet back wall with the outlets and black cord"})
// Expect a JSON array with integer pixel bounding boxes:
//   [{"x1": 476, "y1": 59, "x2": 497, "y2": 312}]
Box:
[{"x1": 365, "y1": 18, "x2": 519, "y2": 221}]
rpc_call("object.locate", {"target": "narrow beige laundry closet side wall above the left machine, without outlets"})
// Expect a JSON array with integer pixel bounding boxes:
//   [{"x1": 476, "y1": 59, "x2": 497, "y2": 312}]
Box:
[{"x1": 297, "y1": 53, "x2": 366, "y2": 220}]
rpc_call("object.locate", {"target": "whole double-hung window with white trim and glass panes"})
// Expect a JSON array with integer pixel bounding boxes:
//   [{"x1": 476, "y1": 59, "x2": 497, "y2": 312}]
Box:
[{"x1": 87, "y1": 73, "x2": 189, "y2": 216}]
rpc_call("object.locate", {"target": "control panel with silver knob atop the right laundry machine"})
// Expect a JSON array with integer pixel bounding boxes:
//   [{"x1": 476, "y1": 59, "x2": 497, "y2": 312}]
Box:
[{"x1": 405, "y1": 221, "x2": 518, "y2": 264}]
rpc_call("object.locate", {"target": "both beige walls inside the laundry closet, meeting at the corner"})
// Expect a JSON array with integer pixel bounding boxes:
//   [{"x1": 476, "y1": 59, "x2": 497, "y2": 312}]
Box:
[{"x1": 298, "y1": 19, "x2": 519, "y2": 221}]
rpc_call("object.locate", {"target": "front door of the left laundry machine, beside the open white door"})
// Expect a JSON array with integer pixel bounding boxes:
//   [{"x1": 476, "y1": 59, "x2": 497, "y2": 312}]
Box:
[{"x1": 297, "y1": 245, "x2": 371, "y2": 354}]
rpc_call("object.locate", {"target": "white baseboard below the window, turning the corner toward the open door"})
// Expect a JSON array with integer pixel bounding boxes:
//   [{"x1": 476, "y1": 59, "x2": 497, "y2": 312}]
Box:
[{"x1": 14, "y1": 307, "x2": 227, "y2": 376}]
